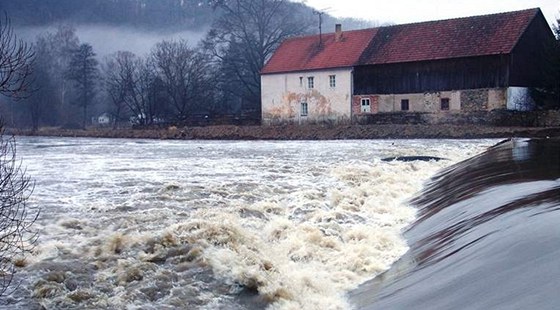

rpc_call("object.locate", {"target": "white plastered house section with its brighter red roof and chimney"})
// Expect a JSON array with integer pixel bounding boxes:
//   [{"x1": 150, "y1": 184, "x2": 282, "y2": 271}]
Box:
[{"x1": 261, "y1": 25, "x2": 375, "y2": 124}]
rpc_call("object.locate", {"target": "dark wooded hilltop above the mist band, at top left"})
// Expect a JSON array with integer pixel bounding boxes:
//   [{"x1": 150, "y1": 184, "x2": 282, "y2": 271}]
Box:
[{"x1": 0, "y1": 0, "x2": 216, "y2": 29}]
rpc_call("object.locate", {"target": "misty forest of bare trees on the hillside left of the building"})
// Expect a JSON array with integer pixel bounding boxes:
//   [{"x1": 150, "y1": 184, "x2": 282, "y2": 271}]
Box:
[{"x1": 0, "y1": 0, "x2": 372, "y2": 130}]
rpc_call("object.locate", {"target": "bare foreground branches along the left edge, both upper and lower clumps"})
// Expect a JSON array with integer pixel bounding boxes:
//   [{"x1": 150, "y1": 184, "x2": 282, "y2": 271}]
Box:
[{"x1": 0, "y1": 12, "x2": 38, "y2": 296}]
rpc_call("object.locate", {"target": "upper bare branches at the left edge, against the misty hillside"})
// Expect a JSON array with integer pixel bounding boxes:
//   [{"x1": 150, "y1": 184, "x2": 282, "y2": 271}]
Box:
[{"x1": 0, "y1": 14, "x2": 35, "y2": 97}]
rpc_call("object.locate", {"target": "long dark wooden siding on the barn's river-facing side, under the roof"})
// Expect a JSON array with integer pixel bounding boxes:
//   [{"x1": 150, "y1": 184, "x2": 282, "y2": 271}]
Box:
[{"x1": 354, "y1": 55, "x2": 510, "y2": 95}]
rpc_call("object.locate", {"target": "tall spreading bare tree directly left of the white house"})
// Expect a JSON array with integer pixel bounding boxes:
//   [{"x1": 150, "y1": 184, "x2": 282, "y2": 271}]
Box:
[{"x1": 204, "y1": 0, "x2": 310, "y2": 114}]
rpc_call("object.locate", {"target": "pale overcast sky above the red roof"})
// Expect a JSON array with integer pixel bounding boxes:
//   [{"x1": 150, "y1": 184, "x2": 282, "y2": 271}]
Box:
[{"x1": 302, "y1": 0, "x2": 560, "y2": 24}]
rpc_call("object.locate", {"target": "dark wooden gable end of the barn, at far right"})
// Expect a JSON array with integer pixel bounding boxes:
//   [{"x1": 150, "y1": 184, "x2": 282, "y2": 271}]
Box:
[{"x1": 509, "y1": 12, "x2": 554, "y2": 87}]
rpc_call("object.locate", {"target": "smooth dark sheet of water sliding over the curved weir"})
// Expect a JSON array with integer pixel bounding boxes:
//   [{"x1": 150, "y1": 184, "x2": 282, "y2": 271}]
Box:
[{"x1": 350, "y1": 139, "x2": 560, "y2": 309}]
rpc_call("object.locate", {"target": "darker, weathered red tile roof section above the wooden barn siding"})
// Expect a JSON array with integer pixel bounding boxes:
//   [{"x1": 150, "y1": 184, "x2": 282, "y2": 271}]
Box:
[{"x1": 360, "y1": 9, "x2": 540, "y2": 64}]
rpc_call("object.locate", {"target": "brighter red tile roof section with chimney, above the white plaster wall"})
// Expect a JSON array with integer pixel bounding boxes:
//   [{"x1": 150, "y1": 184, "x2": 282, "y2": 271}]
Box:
[{"x1": 261, "y1": 28, "x2": 377, "y2": 74}]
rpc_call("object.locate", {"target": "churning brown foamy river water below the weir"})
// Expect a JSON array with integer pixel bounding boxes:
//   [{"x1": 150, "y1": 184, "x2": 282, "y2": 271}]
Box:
[{"x1": 5, "y1": 137, "x2": 497, "y2": 309}]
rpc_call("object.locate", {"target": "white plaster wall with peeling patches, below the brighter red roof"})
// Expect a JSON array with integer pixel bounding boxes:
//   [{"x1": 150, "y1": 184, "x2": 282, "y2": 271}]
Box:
[{"x1": 261, "y1": 68, "x2": 352, "y2": 124}]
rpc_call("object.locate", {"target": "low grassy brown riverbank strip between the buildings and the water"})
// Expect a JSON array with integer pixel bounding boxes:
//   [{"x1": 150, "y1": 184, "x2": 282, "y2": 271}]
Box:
[{"x1": 8, "y1": 125, "x2": 560, "y2": 140}]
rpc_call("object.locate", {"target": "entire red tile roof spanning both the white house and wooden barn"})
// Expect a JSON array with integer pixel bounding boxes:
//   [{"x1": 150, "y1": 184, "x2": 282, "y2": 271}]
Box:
[{"x1": 261, "y1": 9, "x2": 542, "y2": 74}]
